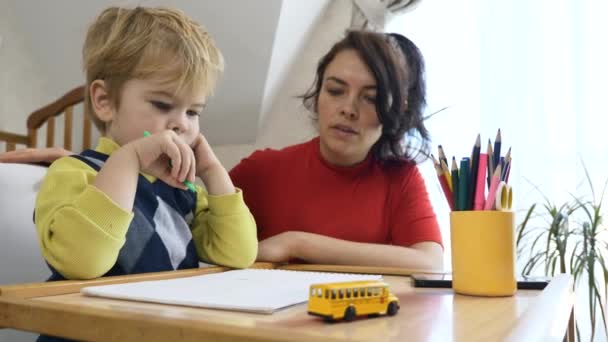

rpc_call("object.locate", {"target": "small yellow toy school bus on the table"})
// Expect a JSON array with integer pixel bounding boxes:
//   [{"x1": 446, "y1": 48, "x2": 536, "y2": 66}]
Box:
[{"x1": 308, "y1": 280, "x2": 399, "y2": 321}]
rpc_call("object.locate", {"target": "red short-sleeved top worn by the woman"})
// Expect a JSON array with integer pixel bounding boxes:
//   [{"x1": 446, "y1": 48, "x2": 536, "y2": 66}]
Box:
[{"x1": 230, "y1": 137, "x2": 442, "y2": 246}]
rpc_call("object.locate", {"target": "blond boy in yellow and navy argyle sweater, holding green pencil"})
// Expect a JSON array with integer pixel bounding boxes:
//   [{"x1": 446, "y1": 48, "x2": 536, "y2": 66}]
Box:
[{"x1": 35, "y1": 7, "x2": 257, "y2": 280}]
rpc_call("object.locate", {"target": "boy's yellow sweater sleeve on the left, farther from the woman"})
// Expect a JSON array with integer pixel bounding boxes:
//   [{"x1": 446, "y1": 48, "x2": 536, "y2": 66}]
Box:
[{"x1": 35, "y1": 157, "x2": 133, "y2": 279}]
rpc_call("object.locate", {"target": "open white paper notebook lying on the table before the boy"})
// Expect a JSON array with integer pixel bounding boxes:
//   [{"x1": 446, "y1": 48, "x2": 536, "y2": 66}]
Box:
[{"x1": 80, "y1": 269, "x2": 382, "y2": 314}]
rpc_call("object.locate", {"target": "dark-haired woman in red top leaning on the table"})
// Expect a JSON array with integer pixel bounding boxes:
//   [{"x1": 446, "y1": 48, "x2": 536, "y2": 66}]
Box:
[{"x1": 230, "y1": 31, "x2": 443, "y2": 269}]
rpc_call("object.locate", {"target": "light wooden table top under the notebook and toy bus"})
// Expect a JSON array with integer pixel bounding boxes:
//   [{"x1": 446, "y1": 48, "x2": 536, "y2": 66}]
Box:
[{"x1": 0, "y1": 263, "x2": 574, "y2": 342}]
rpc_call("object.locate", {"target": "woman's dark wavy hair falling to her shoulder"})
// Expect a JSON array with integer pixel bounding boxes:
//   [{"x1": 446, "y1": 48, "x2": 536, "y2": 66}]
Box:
[{"x1": 300, "y1": 31, "x2": 430, "y2": 163}]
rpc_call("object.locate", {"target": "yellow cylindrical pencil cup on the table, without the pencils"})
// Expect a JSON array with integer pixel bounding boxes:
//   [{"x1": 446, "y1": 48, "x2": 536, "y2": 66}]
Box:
[{"x1": 450, "y1": 210, "x2": 517, "y2": 297}]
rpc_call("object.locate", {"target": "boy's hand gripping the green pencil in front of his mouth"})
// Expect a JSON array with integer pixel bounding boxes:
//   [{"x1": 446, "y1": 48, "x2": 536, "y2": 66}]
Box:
[{"x1": 127, "y1": 130, "x2": 196, "y2": 190}]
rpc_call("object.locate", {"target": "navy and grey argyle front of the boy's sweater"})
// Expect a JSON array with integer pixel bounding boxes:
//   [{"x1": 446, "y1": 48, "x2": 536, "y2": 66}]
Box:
[{"x1": 44, "y1": 150, "x2": 198, "y2": 280}]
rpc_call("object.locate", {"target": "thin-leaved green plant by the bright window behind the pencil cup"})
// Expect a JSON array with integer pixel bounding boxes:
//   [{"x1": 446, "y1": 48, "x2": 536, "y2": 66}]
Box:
[{"x1": 516, "y1": 165, "x2": 608, "y2": 341}]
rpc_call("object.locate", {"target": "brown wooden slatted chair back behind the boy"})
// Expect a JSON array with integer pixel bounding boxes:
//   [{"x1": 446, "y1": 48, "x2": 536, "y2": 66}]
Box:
[{"x1": 0, "y1": 86, "x2": 91, "y2": 152}]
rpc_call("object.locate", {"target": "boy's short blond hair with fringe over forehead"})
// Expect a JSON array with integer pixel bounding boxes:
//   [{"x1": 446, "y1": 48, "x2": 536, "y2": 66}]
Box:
[{"x1": 82, "y1": 7, "x2": 224, "y2": 133}]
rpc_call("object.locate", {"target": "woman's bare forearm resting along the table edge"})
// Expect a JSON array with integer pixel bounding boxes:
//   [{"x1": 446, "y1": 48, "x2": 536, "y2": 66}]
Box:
[{"x1": 292, "y1": 232, "x2": 443, "y2": 270}]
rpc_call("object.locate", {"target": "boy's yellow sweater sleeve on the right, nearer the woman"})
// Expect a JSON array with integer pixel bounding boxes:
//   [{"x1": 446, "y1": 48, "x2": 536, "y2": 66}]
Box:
[{"x1": 192, "y1": 188, "x2": 258, "y2": 268}]
